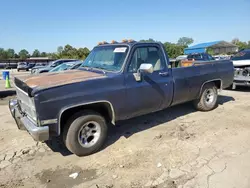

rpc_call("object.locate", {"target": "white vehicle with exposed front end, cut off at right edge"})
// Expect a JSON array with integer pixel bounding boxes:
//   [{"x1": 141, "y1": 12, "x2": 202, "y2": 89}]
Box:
[{"x1": 231, "y1": 49, "x2": 250, "y2": 89}]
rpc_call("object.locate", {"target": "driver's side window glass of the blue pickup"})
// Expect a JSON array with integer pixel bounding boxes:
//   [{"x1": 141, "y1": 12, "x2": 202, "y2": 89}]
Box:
[{"x1": 128, "y1": 47, "x2": 164, "y2": 73}]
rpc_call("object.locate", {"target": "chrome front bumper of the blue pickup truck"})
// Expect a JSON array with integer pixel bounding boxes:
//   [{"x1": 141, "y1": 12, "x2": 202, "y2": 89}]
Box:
[{"x1": 9, "y1": 99, "x2": 49, "y2": 141}]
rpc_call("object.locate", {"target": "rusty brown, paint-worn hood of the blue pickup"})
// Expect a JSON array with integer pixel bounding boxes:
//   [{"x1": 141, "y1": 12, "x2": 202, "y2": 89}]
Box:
[{"x1": 15, "y1": 70, "x2": 106, "y2": 91}]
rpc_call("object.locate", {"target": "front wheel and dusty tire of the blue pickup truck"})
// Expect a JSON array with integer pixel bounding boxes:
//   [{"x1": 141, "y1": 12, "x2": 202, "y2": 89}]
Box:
[{"x1": 63, "y1": 111, "x2": 108, "y2": 156}]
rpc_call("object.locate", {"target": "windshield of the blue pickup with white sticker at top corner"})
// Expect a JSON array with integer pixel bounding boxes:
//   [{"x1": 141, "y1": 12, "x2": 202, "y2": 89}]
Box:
[{"x1": 81, "y1": 46, "x2": 128, "y2": 71}]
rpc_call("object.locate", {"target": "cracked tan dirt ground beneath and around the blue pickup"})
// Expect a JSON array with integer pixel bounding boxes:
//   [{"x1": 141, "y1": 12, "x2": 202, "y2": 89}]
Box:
[{"x1": 0, "y1": 71, "x2": 250, "y2": 188}]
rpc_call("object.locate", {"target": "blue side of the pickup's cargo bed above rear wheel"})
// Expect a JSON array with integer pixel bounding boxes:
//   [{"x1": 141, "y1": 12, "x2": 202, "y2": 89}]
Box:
[{"x1": 172, "y1": 60, "x2": 233, "y2": 105}]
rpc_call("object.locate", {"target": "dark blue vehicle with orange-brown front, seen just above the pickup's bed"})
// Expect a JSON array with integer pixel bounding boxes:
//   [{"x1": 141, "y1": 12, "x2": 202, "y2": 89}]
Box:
[{"x1": 181, "y1": 53, "x2": 215, "y2": 67}]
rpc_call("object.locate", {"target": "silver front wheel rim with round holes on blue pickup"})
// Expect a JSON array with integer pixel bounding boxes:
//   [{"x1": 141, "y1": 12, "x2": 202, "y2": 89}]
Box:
[{"x1": 78, "y1": 121, "x2": 101, "y2": 148}]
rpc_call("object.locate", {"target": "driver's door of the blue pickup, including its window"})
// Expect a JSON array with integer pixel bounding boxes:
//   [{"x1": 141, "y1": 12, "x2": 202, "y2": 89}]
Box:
[{"x1": 124, "y1": 44, "x2": 173, "y2": 118}]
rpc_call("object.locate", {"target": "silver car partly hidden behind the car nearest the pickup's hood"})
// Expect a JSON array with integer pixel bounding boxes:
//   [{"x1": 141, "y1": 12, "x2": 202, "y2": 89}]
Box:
[{"x1": 31, "y1": 59, "x2": 77, "y2": 74}]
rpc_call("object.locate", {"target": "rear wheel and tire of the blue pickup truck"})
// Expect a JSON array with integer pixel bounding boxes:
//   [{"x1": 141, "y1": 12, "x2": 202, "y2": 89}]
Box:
[{"x1": 193, "y1": 83, "x2": 218, "y2": 111}]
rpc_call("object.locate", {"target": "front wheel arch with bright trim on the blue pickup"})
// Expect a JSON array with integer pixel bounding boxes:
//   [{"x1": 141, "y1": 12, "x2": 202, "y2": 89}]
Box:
[{"x1": 58, "y1": 100, "x2": 115, "y2": 135}]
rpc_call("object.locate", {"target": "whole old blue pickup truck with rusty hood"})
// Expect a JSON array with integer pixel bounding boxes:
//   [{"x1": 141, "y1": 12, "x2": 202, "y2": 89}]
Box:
[{"x1": 9, "y1": 41, "x2": 234, "y2": 156}]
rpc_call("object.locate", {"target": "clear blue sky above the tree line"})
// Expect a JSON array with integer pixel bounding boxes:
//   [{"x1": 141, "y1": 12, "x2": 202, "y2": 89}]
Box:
[{"x1": 0, "y1": 0, "x2": 250, "y2": 52}]
